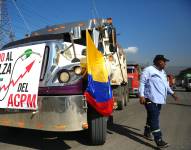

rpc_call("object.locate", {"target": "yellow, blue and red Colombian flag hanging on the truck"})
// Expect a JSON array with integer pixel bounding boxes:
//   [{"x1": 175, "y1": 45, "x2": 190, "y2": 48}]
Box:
[{"x1": 85, "y1": 30, "x2": 113, "y2": 116}]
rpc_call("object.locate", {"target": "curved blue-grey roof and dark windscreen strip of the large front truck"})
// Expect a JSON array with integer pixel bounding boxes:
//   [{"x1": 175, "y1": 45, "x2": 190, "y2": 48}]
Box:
[{"x1": 2, "y1": 18, "x2": 112, "y2": 49}]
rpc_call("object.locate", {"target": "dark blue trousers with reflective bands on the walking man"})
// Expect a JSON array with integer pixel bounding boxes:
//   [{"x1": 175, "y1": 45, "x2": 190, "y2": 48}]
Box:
[{"x1": 145, "y1": 99, "x2": 162, "y2": 141}]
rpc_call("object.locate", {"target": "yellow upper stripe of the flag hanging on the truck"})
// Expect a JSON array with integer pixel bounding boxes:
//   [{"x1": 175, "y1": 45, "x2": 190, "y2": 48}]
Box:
[{"x1": 86, "y1": 30, "x2": 108, "y2": 82}]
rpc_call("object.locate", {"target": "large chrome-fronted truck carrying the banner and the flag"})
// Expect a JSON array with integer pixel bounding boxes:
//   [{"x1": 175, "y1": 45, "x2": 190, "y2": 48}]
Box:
[{"x1": 0, "y1": 18, "x2": 128, "y2": 145}]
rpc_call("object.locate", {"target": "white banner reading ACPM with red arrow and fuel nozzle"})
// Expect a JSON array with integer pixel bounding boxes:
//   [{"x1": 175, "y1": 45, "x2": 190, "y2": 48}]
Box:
[{"x1": 0, "y1": 44, "x2": 45, "y2": 110}]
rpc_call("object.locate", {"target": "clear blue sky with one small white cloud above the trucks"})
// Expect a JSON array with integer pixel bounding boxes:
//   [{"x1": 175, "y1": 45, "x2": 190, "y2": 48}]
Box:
[{"x1": 7, "y1": 0, "x2": 191, "y2": 66}]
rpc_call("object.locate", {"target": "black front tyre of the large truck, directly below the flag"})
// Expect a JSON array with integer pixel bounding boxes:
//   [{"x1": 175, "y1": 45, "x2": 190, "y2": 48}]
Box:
[{"x1": 88, "y1": 106, "x2": 107, "y2": 145}]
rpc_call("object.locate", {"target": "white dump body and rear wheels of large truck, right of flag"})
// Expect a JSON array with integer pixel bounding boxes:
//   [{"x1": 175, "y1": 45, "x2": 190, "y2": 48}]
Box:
[{"x1": 109, "y1": 44, "x2": 129, "y2": 110}]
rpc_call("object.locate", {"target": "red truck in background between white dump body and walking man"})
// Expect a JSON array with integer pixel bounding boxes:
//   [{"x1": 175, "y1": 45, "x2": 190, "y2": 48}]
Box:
[{"x1": 127, "y1": 64, "x2": 141, "y2": 97}]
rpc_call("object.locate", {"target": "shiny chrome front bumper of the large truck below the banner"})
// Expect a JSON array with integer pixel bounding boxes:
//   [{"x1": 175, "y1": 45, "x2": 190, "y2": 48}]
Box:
[{"x1": 0, "y1": 95, "x2": 88, "y2": 131}]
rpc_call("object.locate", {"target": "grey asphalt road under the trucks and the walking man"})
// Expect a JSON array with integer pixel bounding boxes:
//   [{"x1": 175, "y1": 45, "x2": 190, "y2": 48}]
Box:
[{"x1": 0, "y1": 89, "x2": 191, "y2": 150}]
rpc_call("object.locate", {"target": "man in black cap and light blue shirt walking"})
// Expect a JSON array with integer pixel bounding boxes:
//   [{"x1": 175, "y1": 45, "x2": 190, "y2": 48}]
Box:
[{"x1": 139, "y1": 55, "x2": 178, "y2": 148}]
